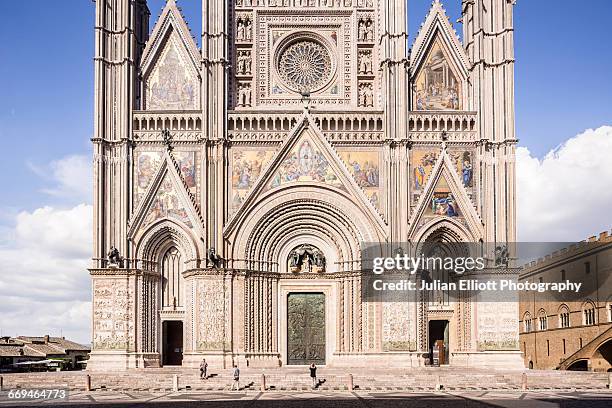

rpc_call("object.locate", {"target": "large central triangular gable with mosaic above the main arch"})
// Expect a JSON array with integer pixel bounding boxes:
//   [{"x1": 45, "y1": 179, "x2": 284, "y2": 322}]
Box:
[{"x1": 226, "y1": 114, "x2": 384, "y2": 236}]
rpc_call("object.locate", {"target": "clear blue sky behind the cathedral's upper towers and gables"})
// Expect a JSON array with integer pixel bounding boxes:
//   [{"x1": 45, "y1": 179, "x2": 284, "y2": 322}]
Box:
[{"x1": 0, "y1": 0, "x2": 612, "y2": 212}]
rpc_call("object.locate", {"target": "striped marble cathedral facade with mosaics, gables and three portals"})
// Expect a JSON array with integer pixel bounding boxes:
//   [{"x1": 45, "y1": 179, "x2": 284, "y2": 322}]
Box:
[{"x1": 88, "y1": 0, "x2": 522, "y2": 370}]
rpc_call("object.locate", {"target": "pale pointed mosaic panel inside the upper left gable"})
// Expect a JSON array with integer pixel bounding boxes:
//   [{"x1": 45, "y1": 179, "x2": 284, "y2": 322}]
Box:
[{"x1": 146, "y1": 35, "x2": 200, "y2": 110}]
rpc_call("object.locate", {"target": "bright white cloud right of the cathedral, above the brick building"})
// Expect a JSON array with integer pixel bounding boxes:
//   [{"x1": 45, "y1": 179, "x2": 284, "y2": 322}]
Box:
[{"x1": 516, "y1": 126, "x2": 612, "y2": 242}]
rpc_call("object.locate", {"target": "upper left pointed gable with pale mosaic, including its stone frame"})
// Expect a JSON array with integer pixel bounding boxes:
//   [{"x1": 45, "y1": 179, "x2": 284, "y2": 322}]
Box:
[{"x1": 141, "y1": 0, "x2": 200, "y2": 110}]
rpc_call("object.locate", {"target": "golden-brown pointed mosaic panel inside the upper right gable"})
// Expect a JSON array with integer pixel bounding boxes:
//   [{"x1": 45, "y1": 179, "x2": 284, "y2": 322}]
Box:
[{"x1": 415, "y1": 38, "x2": 462, "y2": 110}]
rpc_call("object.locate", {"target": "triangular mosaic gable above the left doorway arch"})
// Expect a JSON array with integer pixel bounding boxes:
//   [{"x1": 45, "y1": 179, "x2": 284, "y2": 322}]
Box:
[{"x1": 128, "y1": 151, "x2": 204, "y2": 238}]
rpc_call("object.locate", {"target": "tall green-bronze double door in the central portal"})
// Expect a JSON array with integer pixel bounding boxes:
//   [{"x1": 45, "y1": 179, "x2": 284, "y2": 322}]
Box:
[{"x1": 287, "y1": 293, "x2": 325, "y2": 365}]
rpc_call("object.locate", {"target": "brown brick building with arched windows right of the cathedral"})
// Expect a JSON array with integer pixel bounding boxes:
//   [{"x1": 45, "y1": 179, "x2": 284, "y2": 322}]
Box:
[{"x1": 519, "y1": 232, "x2": 612, "y2": 371}]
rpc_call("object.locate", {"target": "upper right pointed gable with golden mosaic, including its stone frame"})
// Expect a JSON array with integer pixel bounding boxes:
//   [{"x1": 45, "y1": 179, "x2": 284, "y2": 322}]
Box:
[{"x1": 410, "y1": 0, "x2": 469, "y2": 110}]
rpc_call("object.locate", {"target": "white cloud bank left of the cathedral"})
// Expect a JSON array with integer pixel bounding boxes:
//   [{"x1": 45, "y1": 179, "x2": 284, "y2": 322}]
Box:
[{"x1": 0, "y1": 156, "x2": 93, "y2": 343}]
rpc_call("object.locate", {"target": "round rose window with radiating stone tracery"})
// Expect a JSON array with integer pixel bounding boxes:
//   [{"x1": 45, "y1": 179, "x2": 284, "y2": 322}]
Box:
[{"x1": 278, "y1": 40, "x2": 332, "y2": 92}]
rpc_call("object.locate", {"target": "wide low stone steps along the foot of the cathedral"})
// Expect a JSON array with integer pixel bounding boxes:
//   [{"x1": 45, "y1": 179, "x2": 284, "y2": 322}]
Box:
[{"x1": 2, "y1": 369, "x2": 608, "y2": 391}]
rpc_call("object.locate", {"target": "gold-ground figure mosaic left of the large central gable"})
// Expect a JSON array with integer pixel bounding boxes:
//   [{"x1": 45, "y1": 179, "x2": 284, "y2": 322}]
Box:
[{"x1": 231, "y1": 148, "x2": 275, "y2": 212}]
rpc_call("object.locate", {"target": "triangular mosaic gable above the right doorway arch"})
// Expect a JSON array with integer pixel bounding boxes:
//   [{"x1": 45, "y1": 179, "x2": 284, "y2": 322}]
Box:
[{"x1": 409, "y1": 147, "x2": 484, "y2": 239}]
